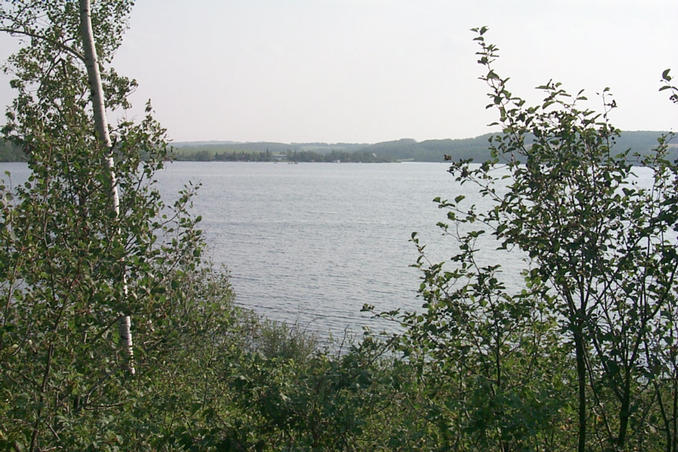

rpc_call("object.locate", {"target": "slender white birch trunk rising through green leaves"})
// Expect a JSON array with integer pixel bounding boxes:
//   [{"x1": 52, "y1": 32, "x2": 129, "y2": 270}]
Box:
[{"x1": 80, "y1": 0, "x2": 135, "y2": 375}]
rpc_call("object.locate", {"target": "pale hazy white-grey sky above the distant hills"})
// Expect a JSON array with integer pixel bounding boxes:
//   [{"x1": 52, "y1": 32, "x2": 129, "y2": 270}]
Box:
[{"x1": 0, "y1": 0, "x2": 678, "y2": 143}]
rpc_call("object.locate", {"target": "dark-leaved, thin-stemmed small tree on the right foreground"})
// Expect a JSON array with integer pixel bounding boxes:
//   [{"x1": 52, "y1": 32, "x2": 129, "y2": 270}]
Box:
[{"x1": 372, "y1": 28, "x2": 678, "y2": 451}]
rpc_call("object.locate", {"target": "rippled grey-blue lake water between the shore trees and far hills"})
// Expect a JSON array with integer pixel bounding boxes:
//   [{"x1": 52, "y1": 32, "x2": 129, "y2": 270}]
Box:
[{"x1": 0, "y1": 162, "x2": 522, "y2": 340}]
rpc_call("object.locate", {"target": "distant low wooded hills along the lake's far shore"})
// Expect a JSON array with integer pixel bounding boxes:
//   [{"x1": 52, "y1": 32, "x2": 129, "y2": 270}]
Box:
[{"x1": 0, "y1": 131, "x2": 678, "y2": 163}]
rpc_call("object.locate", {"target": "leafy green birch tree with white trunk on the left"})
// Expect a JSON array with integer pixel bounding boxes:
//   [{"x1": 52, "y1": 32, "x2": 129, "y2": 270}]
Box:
[{"x1": 0, "y1": 0, "x2": 202, "y2": 450}]
